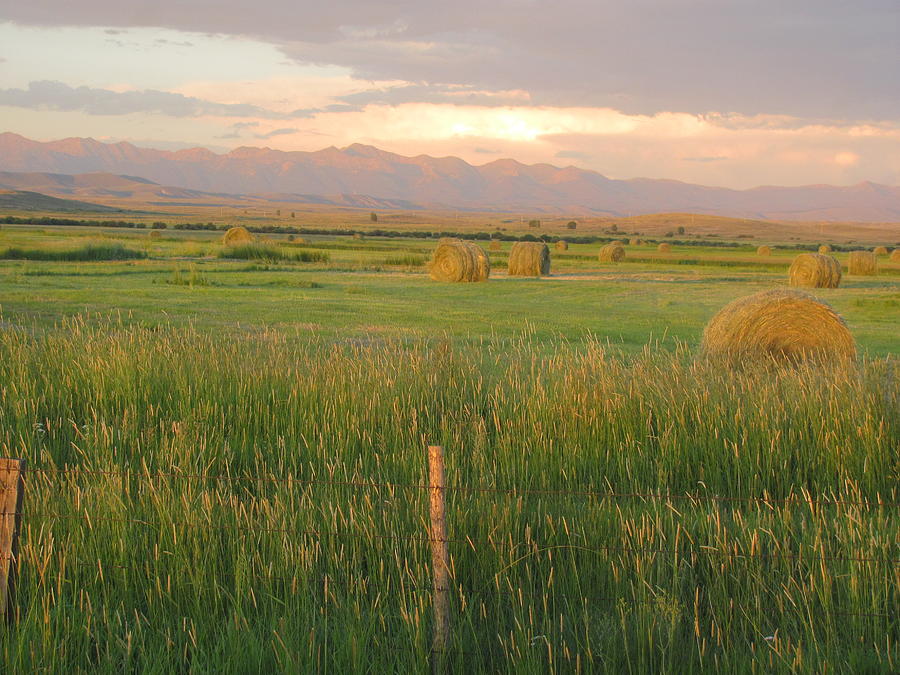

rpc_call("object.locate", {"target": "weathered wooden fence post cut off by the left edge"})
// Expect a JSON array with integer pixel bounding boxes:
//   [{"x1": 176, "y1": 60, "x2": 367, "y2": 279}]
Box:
[{"x1": 0, "y1": 459, "x2": 25, "y2": 619}]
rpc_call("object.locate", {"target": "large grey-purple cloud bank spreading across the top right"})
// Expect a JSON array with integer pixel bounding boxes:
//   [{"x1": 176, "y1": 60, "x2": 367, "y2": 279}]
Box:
[{"x1": 4, "y1": 0, "x2": 900, "y2": 119}]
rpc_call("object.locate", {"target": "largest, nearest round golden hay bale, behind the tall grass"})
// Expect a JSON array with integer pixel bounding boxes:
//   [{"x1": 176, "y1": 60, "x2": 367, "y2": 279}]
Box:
[{"x1": 701, "y1": 290, "x2": 856, "y2": 364}]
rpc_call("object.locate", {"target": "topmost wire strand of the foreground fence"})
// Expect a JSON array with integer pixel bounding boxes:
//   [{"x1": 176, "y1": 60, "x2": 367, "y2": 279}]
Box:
[{"x1": 27, "y1": 468, "x2": 900, "y2": 508}]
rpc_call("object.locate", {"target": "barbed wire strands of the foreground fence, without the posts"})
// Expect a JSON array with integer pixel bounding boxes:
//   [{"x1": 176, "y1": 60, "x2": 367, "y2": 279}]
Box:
[{"x1": 0, "y1": 454, "x2": 900, "y2": 640}]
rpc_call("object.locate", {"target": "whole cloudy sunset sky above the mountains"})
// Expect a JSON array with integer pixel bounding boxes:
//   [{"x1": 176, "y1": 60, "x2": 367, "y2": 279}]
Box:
[{"x1": 0, "y1": 0, "x2": 900, "y2": 188}]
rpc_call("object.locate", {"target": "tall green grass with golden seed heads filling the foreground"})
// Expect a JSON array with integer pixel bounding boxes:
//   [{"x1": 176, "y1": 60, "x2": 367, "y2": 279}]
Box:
[{"x1": 0, "y1": 320, "x2": 900, "y2": 673}]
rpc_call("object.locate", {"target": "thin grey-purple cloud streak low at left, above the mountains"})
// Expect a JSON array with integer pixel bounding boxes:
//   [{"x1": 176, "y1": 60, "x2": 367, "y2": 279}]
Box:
[{"x1": 0, "y1": 80, "x2": 312, "y2": 119}]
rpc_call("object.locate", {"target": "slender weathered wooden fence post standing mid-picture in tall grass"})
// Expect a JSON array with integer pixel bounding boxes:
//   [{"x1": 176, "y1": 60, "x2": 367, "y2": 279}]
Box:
[{"x1": 428, "y1": 445, "x2": 450, "y2": 674}]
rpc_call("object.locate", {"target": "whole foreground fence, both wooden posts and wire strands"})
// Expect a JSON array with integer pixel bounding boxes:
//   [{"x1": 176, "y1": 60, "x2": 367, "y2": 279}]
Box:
[{"x1": 0, "y1": 446, "x2": 900, "y2": 672}]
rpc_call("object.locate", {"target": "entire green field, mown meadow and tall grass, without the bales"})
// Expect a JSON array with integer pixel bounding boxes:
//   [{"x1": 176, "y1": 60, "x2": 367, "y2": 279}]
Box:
[{"x1": 0, "y1": 226, "x2": 900, "y2": 673}]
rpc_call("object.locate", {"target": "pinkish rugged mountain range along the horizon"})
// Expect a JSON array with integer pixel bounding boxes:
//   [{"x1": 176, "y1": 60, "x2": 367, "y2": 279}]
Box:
[{"x1": 0, "y1": 133, "x2": 900, "y2": 222}]
